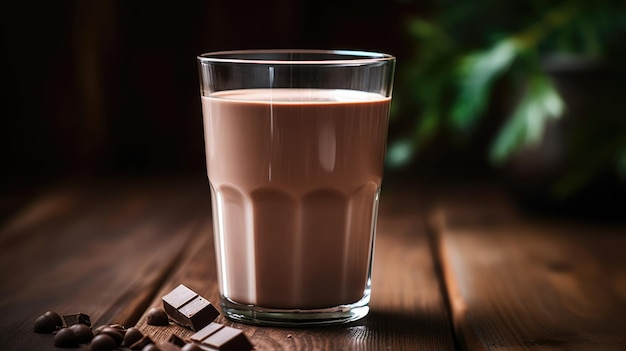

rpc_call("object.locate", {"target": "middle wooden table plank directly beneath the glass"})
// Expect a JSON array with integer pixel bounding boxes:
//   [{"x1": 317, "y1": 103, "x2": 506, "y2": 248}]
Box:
[{"x1": 133, "y1": 194, "x2": 454, "y2": 351}]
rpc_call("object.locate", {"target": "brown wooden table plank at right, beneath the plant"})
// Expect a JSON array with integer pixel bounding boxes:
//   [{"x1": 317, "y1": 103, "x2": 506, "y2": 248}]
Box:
[{"x1": 434, "y1": 196, "x2": 626, "y2": 350}]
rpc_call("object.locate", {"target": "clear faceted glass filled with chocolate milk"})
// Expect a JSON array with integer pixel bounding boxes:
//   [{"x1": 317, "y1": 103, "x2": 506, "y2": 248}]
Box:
[{"x1": 198, "y1": 50, "x2": 395, "y2": 326}]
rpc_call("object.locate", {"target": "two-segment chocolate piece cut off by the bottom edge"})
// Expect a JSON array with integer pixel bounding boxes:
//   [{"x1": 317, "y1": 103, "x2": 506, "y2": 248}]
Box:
[{"x1": 190, "y1": 323, "x2": 253, "y2": 351}]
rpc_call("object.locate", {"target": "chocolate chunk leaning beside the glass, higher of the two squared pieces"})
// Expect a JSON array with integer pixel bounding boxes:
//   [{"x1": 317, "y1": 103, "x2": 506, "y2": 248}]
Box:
[{"x1": 162, "y1": 284, "x2": 220, "y2": 331}]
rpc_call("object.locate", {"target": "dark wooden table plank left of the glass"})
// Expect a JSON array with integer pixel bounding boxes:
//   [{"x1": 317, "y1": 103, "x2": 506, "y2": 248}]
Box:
[{"x1": 0, "y1": 181, "x2": 210, "y2": 350}]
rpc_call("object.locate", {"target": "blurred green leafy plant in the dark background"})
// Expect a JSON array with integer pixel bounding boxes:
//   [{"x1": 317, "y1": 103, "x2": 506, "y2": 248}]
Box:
[{"x1": 388, "y1": 0, "x2": 626, "y2": 193}]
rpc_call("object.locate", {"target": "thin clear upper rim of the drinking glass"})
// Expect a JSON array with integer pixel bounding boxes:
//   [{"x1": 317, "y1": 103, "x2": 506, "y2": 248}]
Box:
[{"x1": 197, "y1": 49, "x2": 396, "y2": 66}]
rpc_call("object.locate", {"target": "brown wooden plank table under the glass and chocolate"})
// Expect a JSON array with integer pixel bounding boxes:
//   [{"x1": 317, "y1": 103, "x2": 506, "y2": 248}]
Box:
[{"x1": 0, "y1": 178, "x2": 626, "y2": 350}]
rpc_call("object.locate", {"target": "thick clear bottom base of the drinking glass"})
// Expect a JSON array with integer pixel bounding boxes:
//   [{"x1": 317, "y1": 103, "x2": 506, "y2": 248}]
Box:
[{"x1": 221, "y1": 294, "x2": 370, "y2": 327}]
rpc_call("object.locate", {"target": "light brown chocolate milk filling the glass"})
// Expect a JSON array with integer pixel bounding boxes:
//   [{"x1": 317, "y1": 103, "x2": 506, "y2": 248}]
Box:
[{"x1": 202, "y1": 89, "x2": 390, "y2": 309}]
